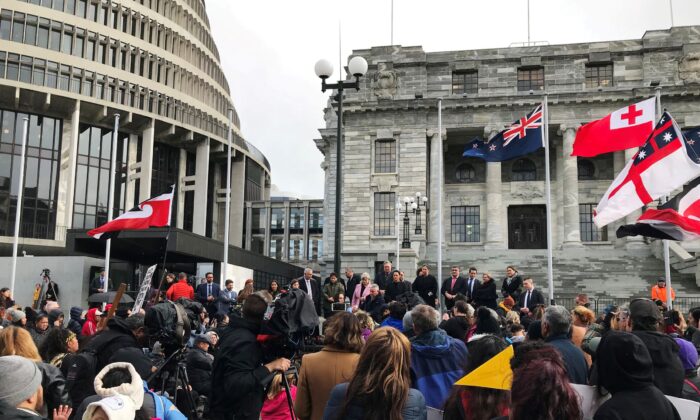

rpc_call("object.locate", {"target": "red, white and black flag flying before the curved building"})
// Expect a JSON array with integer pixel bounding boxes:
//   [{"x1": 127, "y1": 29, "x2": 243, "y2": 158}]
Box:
[{"x1": 88, "y1": 186, "x2": 175, "y2": 239}]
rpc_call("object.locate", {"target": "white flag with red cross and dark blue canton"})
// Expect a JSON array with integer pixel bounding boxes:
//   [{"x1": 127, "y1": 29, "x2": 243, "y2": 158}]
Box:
[{"x1": 593, "y1": 112, "x2": 700, "y2": 227}]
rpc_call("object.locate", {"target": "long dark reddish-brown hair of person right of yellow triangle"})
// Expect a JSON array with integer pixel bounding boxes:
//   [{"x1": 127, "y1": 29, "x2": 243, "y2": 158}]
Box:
[{"x1": 510, "y1": 346, "x2": 583, "y2": 420}]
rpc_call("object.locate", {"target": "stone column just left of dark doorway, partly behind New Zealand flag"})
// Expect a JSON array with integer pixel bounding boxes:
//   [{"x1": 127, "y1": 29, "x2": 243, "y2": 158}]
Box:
[{"x1": 484, "y1": 127, "x2": 506, "y2": 249}]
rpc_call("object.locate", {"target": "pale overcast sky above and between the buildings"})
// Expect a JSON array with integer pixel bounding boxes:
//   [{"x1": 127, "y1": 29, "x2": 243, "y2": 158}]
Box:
[{"x1": 206, "y1": 0, "x2": 700, "y2": 198}]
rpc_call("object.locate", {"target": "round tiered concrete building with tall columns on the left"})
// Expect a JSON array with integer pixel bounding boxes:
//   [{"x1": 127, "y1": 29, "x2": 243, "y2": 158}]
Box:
[{"x1": 0, "y1": 0, "x2": 270, "y2": 249}]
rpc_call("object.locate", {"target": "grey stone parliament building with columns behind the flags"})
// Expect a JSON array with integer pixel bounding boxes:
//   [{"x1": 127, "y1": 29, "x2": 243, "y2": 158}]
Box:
[{"x1": 315, "y1": 26, "x2": 700, "y2": 297}]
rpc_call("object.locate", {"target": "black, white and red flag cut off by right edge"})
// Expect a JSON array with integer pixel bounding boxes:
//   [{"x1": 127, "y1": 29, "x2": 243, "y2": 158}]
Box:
[{"x1": 617, "y1": 178, "x2": 700, "y2": 241}]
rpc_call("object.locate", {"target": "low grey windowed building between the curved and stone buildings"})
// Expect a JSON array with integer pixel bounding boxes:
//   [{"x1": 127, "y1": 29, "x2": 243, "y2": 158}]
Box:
[{"x1": 243, "y1": 197, "x2": 324, "y2": 271}]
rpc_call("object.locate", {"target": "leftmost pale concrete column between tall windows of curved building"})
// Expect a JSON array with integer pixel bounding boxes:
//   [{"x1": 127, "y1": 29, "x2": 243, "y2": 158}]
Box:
[{"x1": 55, "y1": 101, "x2": 80, "y2": 235}]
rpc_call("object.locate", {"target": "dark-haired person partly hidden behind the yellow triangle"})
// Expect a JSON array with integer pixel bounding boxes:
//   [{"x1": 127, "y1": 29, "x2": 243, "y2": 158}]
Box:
[{"x1": 443, "y1": 335, "x2": 510, "y2": 420}]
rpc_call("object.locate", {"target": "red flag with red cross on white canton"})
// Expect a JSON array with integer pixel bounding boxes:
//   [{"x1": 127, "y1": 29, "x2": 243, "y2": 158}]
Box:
[{"x1": 571, "y1": 98, "x2": 656, "y2": 157}]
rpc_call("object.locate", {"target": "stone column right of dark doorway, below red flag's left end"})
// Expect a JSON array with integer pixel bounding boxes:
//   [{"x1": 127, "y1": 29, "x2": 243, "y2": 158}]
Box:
[{"x1": 559, "y1": 124, "x2": 582, "y2": 248}]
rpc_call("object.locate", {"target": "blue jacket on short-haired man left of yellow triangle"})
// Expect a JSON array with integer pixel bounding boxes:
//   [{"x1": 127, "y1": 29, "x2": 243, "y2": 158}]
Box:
[{"x1": 411, "y1": 329, "x2": 467, "y2": 409}]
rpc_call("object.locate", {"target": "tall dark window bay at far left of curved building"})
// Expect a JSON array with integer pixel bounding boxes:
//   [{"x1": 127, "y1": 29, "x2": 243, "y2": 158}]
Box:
[{"x1": 0, "y1": 110, "x2": 62, "y2": 239}]
